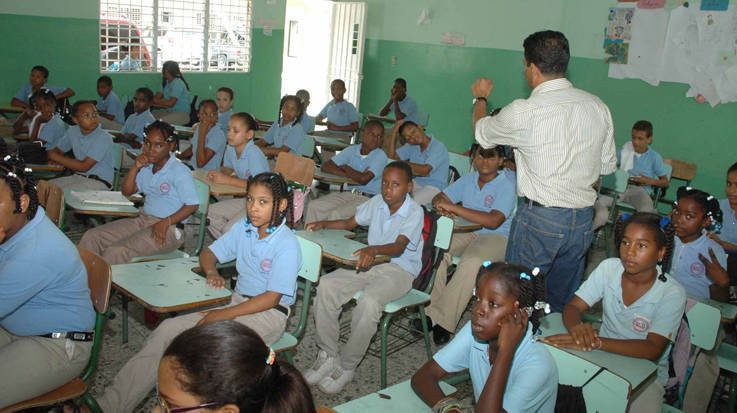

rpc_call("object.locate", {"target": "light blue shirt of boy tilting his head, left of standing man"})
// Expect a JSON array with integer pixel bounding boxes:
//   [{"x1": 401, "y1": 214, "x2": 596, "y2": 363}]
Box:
[{"x1": 397, "y1": 134, "x2": 450, "y2": 205}]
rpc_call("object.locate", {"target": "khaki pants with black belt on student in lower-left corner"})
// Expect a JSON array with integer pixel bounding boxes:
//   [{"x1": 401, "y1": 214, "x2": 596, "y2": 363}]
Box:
[{"x1": 0, "y1": 328, "x2": 92, "y2": 408}]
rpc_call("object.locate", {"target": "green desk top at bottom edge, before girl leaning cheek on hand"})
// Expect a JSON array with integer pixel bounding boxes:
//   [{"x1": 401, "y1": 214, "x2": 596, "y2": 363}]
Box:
[{"x1": 333, "y1": 380, "x2": 456, "y2": 413}]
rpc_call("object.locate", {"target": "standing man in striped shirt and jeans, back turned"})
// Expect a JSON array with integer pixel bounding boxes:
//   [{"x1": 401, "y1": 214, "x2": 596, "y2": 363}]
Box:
[{"x1": 471, "y1": 31, "x2": 617, "y2": 311}]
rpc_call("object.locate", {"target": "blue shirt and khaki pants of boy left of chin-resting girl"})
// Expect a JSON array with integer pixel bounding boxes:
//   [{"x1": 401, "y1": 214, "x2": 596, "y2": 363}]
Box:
[{"x1": 50, "y1": 125, "x2": 115, "y2": 191}]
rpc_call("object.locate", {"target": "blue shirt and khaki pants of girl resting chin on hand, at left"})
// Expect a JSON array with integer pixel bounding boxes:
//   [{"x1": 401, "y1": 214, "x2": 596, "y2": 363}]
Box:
[{"x1": 79, "y1": 156, "x2": 200, "y2": 265}]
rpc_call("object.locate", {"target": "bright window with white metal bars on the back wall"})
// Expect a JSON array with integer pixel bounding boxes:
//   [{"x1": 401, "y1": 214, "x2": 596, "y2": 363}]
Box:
[{"x1": 100, "y1": 0, "x2": 252, "y2": 72}]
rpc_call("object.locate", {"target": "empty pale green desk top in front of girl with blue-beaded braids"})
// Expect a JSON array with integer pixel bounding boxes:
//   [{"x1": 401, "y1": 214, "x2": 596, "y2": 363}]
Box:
[{"x1": 112, "y1": 257, "x2": 231, "y2": 313}]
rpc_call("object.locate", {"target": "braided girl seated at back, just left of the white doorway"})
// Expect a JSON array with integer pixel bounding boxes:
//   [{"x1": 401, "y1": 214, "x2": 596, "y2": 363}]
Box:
[{"x1": 256, "y1": 95, "x2": 306, "y2": 159}]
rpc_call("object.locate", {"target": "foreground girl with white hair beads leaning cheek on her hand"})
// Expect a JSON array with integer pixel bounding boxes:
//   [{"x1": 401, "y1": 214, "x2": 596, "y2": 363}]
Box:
[{"x1": 412, "y1": 261, "x2": 558, "y2": 412}]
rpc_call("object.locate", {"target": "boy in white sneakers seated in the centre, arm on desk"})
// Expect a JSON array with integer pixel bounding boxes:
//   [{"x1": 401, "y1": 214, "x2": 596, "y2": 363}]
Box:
[{"x1": 305, "y1": 161, "x2": 424, "y2": 394}]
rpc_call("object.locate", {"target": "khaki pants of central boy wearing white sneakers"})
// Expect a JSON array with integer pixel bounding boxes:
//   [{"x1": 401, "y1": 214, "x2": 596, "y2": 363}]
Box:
[{"x1": 315, "y1": 263, "x2": 414, "y2": 370}]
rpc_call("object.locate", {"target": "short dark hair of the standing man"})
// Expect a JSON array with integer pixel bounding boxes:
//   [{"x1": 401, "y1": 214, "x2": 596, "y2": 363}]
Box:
[{"x1": 522, "y1": 30, "x2": 571, "y2": 76}]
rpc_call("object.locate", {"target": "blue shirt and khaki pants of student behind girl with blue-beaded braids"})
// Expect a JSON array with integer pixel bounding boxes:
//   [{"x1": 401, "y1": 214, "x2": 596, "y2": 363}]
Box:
[{"x1": 207, "y1": 140, "x2": 269, "y2": 239}]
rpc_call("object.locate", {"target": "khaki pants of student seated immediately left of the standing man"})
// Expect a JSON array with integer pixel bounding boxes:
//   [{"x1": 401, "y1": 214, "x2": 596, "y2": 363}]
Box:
[{"x1": 426, "y1": 232, "x2": 507, "y2": 332}]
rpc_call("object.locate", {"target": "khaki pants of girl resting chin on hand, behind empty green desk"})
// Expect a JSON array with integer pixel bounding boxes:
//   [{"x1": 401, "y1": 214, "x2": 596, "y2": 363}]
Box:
[{"x1": 79, "y1": 214, "x2": 184, "y2": 265}]
